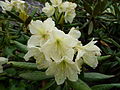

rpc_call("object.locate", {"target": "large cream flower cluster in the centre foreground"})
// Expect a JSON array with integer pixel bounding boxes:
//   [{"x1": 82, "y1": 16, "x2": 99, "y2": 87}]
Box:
[{"x1": 24, "y1": 17, "x2": 100, "y2": 85}]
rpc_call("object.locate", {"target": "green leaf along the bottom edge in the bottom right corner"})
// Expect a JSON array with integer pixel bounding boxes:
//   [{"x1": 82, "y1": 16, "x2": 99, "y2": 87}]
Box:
[{"x1": 92, "y1": 83, "x2": 120, "y2": 90}]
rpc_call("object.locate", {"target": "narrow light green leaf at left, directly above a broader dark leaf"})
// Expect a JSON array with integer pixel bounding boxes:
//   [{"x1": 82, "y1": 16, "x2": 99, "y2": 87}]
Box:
[{"x1": 7, "y1": 61, "x2": 37, "y2": 69}]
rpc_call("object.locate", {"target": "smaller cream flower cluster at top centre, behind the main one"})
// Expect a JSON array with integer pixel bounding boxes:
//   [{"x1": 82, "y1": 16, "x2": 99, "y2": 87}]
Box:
[{"x1": 42, "y1": 0, "x2": 77, "y2": 23}]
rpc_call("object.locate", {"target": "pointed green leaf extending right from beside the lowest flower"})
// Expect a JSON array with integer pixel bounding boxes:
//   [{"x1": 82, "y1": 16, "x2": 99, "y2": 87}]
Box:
[{"x1": 84, "y1": 73, "x2": 114, "y2": 81}]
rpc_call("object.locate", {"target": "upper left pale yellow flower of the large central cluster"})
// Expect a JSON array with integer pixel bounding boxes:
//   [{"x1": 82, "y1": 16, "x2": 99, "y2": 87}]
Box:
[{"x1": 28, "y1": 18, "x2": 57, "y2": 47}]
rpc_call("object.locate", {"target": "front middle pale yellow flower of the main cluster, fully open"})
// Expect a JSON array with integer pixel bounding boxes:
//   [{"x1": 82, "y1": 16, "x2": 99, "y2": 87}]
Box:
[{"x1": 41, "y1": 30, "x2": 77, "y2": 62}]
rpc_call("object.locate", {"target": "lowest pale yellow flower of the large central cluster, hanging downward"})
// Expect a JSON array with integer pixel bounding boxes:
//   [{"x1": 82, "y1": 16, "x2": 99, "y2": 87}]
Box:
[{"x1": 46, "y1": 57, "x2": 80, "y2": 85}]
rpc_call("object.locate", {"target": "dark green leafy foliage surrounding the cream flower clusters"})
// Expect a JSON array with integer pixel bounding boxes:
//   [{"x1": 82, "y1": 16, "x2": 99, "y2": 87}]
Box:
[{"x1": 0, "y1": 0, "x2": 120, "y2": 90}]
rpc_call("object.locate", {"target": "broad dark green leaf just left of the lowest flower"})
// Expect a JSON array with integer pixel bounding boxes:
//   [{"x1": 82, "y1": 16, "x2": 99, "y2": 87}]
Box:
[{"x1": 19, "y1": 71, "x2": 52, "y2": 81}]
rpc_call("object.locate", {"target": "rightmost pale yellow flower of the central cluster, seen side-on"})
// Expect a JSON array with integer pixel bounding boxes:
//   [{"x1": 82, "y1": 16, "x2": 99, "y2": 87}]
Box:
[{"x1": 75, "y1": 40, "x2": 101, "y2": 68}]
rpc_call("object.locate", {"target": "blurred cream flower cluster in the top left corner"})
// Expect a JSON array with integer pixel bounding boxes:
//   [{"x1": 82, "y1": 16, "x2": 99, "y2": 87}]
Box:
[{"x1": 0, "y1": 0, "x2": 25, "y2": 12}]
